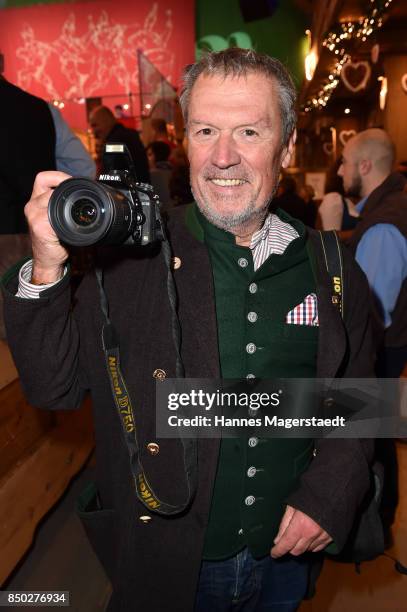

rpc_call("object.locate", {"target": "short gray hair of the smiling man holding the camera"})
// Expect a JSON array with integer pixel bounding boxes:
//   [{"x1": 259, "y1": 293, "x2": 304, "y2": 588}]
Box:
[{"x1": 179, "y1": 47, "x2": 297, "y2": 145}]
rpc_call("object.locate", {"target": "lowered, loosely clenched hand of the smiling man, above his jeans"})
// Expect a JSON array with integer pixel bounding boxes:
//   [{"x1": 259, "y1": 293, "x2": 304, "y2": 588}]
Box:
[{"x1": 270, "y1": 506, "x2": 332, "y2": 559}]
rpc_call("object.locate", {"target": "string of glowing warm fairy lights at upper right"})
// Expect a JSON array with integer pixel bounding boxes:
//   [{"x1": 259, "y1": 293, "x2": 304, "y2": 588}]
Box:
[{"x1": 301, "y1": 0, "x2": 392, "y2": 113}]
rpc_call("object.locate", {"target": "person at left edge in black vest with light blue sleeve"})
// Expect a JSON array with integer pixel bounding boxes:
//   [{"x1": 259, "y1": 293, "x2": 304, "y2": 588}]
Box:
[{"x1": 0, "y1": 54, "x2": 95, "y2": 234}]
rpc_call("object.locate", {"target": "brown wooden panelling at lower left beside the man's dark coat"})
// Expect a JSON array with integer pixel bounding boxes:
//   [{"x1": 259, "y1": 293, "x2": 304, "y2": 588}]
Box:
[{"x1": 0, "y1": 341, "x2": 93, "y2": 585}]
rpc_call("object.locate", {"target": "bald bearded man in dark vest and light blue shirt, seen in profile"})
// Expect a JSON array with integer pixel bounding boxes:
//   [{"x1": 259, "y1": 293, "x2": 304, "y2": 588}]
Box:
[{"x1": 338, "y1": 128, "x2": 407, "y2": 378}]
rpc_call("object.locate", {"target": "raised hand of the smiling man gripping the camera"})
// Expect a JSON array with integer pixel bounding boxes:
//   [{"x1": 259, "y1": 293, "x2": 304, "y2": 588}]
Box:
[{"x1": 24, "y1": 171, "x2": 70, "y2": 285}]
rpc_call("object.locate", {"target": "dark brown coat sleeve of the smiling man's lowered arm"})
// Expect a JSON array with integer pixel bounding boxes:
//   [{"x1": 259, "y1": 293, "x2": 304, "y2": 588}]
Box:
[{"x1": 287, "y1": 238, "x2": 375, "y2": 550}]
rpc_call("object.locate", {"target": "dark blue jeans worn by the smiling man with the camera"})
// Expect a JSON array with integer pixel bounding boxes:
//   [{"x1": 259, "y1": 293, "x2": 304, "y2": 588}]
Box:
[{"x1": 194, "y1": 548, "x2": 310, "y2": 612}]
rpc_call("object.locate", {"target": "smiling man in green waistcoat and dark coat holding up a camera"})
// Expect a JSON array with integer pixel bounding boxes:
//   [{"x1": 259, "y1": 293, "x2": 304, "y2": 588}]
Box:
[{"x1": 1, "y1": 49, "x2": 371, "y2": 612}]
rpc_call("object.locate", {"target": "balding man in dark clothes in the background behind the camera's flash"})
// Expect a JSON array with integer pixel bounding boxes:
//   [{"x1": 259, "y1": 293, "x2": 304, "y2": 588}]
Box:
[{"x1": 89, "y1": 106, "x2": 150, "y2": 183}]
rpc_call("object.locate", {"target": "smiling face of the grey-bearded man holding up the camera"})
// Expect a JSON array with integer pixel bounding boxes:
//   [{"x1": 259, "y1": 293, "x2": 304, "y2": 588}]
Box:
[{"x1": 188, "y1": 73, "x2": 293, "y2": 230}]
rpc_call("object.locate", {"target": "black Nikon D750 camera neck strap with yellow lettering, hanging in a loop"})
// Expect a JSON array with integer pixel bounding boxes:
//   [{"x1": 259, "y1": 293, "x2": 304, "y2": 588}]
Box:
[{"x1": 95, "y1": 243, "x2": 198, "y2": 516}]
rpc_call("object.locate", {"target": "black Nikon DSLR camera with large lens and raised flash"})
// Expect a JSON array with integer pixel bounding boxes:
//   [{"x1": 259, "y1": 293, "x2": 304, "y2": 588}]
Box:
[{"x1": 48, "y1": 144, "x2": 163, "y2": 247}]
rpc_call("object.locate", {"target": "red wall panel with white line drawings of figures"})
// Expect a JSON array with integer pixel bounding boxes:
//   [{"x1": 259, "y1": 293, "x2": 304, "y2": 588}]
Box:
[{"x1": 0, "y1": 0, "x2": 195, "y2": 128}]
